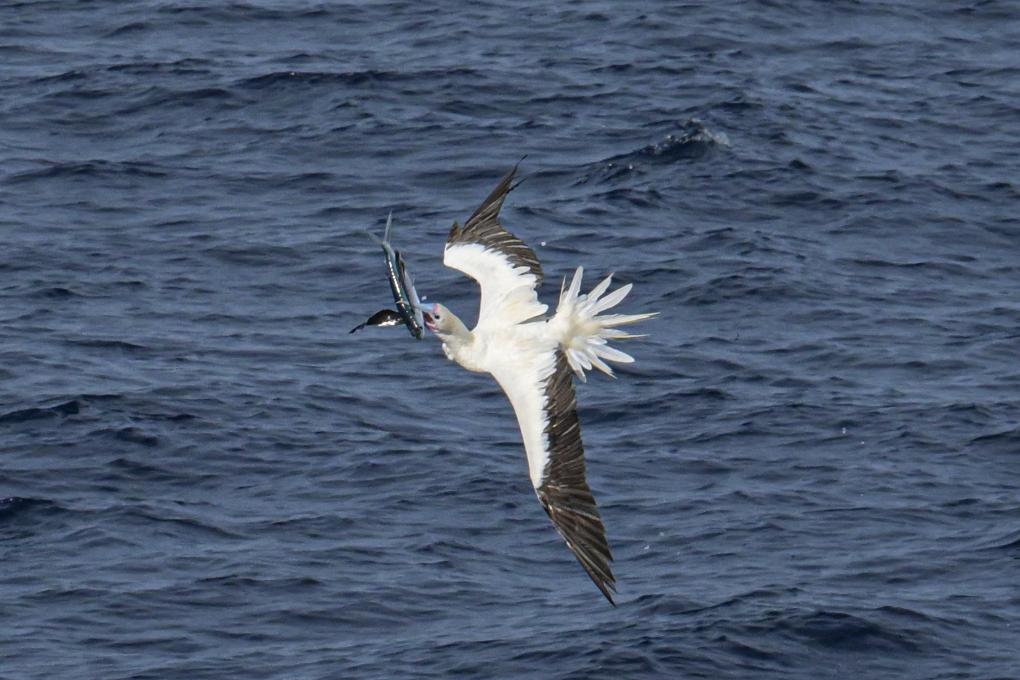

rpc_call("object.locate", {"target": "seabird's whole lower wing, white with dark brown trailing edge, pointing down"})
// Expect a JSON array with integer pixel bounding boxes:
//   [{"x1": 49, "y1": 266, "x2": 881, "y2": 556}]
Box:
[{"x1": 492, "y1": 348, "x2": 616, "y2": 605}]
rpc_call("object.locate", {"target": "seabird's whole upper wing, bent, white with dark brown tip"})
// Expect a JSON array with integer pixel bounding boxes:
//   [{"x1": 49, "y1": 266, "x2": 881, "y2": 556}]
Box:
[{"x1": 443, "y1": 165, "x2": 548, "y2": 326}]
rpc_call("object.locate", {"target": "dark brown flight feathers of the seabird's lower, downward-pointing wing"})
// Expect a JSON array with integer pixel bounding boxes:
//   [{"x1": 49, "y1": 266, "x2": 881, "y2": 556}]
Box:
[{"x1": 537, "y1": 351, "x2": 616, "y2": 607}]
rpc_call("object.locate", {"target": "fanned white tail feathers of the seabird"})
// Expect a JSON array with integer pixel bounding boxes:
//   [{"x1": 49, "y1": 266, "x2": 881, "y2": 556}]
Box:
[{"x1": 552, "y1": 267, "x2": 658, "y2": 382}]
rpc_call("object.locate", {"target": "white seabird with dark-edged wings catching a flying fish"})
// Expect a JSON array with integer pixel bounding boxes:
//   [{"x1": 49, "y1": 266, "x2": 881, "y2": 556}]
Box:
[{"x1": 424, "y1": 166, "x2": 655, "y2": 605}]
